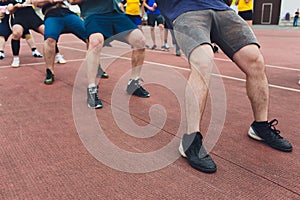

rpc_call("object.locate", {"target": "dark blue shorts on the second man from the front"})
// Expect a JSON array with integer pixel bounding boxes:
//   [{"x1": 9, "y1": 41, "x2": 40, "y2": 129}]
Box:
[{"x1": 84, "y1": 13, "x2": 138, "y2": 42}]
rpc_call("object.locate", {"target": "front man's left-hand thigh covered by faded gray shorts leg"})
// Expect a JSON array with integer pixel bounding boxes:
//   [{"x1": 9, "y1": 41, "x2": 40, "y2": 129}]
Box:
[{"x1": 173, "y1": 10, "x2": 212, "y2": 58}]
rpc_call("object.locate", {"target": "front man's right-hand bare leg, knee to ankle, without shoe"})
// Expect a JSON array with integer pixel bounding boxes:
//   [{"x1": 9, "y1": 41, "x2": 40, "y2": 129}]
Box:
[{"x1": 233, "y1": 45, "x2": 269, "y2": 121}]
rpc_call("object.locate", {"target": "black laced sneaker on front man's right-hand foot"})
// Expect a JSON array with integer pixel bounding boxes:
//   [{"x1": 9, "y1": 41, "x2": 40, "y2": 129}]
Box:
[{"x1": 248, "y1": 119, "x2": 293, "y2": 152}]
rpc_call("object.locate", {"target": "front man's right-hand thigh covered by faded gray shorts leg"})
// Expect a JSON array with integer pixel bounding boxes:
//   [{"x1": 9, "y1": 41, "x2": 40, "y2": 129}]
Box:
[{"x1": 211, "y1": 11, "x2": 259, "y2": 59}]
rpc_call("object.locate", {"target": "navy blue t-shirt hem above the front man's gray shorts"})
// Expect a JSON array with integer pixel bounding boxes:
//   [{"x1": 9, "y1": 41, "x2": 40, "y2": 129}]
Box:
[{"x1": 156, "y1": 0, "x2": 231, "y2": 21}]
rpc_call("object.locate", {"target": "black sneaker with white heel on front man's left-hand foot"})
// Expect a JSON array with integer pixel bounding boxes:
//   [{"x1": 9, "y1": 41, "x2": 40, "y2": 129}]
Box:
[{"x1": 179, "y1": 132, "x2": 217, "y2": 173}]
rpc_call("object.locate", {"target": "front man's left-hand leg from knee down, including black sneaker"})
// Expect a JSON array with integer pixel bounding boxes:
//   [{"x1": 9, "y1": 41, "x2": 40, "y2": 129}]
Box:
[{"x1": 179, "y1": 45, "x2": 217, "y2": 173}]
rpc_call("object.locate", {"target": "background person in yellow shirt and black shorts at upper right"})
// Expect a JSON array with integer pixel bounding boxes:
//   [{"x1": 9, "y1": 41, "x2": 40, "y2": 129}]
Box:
[{"x1": 235, "y1": 0, "x2": 253, "y2": 27}]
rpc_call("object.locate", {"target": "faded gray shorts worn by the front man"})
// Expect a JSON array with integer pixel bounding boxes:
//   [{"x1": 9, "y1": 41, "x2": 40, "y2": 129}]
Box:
[{"x1": 174, "y1": 10, "x2": 259, "y2": 59}]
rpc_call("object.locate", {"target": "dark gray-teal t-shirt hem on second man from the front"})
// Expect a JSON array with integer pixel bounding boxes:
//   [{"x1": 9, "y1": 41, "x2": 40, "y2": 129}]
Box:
[{"x1": 79, "y1": 0, "x2": 122, "y2": 19}]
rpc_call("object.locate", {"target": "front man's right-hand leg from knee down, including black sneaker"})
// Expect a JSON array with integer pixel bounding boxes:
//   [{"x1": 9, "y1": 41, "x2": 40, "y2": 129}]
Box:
[{"x1": 233, "y1": 45, "x2": 293, "y2": 152}]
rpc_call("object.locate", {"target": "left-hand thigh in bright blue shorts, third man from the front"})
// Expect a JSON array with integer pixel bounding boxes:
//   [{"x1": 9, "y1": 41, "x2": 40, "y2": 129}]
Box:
[{"x1": 44, "y1": 17, "x2": 64, "y2": 41}]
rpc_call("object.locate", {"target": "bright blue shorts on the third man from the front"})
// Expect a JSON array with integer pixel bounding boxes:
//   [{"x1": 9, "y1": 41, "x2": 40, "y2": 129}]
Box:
[{"x1": 44, "y1": 14, "x2": 87, "y2": 42}]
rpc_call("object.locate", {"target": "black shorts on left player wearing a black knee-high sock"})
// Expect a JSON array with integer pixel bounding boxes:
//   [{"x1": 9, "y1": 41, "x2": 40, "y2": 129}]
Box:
[{"x1": 13, "y1": 12, "x2": 43, "y2": 32}]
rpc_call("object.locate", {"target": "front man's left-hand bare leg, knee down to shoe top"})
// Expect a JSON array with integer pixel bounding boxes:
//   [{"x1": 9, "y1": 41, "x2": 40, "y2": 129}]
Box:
[{"x1": 185, "y1": 45, "x2": 214, "y2": 134}]
